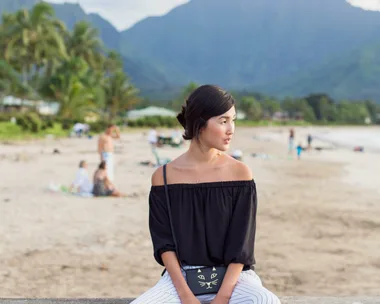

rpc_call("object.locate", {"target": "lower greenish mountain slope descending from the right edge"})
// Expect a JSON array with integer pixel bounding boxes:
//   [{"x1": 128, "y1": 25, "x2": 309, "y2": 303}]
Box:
[{"x1": 260, "y1": 39, "x2": 380, "y2": 101}]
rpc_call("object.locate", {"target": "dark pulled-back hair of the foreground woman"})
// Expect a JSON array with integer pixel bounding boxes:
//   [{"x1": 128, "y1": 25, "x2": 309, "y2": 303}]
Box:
[{"x1": 177, "y1": 85, "x2": 235, "y2": 140}]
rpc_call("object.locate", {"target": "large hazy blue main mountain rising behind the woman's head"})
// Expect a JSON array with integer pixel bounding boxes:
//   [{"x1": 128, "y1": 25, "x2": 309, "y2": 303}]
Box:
[{"x1": 120, "y1": 0, "x2": 380, "y2": 97}]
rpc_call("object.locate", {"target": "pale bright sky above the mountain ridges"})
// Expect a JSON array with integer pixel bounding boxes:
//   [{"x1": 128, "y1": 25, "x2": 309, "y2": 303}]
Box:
[{"x1": 48, "y1": 0, "x2": 380, "y2": 31}]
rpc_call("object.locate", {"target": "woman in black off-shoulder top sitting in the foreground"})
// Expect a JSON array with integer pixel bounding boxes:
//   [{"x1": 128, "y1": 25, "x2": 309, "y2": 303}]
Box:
[{"x1": 132, "y1": 85, "x2": 280, "y2": 304}]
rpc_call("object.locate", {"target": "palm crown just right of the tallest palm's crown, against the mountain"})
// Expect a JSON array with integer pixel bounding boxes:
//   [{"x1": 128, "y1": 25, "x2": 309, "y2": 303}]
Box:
[{"x1": 66, "y1": 21, "x2": 104, "y2": 69}]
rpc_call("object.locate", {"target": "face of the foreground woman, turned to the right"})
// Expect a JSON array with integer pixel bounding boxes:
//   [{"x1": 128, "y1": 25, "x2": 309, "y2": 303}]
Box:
[{"x1": 199, "y1": 106, "x2": 236, "y2": 151}]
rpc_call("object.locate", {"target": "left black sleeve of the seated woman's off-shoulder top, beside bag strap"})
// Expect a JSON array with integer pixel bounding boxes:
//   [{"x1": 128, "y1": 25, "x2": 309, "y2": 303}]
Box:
[{"x1": 149, "y1": 190, "x2": 175, "y2": 266}]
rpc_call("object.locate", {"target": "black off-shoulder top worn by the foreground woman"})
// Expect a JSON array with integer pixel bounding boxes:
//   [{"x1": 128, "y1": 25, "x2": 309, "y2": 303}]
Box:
[{"x1": 149, "y1": 180, "x2": 257, "y2": 270}]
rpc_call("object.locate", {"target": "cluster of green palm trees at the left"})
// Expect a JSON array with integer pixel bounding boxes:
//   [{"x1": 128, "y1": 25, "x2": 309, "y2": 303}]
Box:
[{"x1": 0, "y1": 2, "x2": 139, "y2": 122}]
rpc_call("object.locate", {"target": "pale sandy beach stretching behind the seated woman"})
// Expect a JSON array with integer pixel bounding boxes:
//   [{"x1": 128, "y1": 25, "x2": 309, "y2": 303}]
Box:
[{"x1": 0, "y1": 127, "x2": 380, "y2": 297}]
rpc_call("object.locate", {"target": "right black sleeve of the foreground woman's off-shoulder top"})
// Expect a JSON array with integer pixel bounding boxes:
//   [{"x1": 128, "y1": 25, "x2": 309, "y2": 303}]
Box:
[{"x1": 224, "y1": 181, "x2": 257, "y2": 265}]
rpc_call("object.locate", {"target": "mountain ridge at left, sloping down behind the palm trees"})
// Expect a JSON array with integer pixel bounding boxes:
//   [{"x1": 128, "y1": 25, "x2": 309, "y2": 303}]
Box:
[{"x1": 0, "y1": 0, "x2": 168, "y2": 90}]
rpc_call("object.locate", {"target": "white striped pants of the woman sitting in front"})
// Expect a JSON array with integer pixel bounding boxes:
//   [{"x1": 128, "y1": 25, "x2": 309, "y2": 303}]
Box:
[{"x1": 132, "y1": 266, "x2": 281, "y2": 304}]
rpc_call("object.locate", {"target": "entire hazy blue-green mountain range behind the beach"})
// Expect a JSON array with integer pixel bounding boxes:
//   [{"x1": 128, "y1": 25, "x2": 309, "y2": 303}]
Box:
[{"x1": 0, "y1": 0, "x2": 380, "y2": 102}]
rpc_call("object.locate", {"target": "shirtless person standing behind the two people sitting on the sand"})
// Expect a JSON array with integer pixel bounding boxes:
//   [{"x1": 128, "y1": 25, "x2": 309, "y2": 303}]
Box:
[{"x1": 98, "y1": 124, "x2": 120, "y2": 181}]
